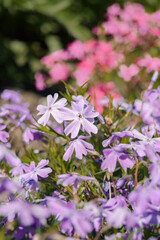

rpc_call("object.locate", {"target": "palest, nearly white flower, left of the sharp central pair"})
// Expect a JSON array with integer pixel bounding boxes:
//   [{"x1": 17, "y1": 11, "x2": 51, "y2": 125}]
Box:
[{"x1": 37, "y1": 93, "x2": 67, "y2": 126}]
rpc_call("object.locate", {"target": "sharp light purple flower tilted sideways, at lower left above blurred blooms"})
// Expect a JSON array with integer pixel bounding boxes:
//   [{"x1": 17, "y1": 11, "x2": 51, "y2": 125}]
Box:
[{"x1": 20, "y1": 159, "x2": 52, "y2": 182}]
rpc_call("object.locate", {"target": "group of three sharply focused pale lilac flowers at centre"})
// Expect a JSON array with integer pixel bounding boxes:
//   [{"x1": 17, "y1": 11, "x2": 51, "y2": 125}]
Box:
[{"x1": 37, "y1": 93, "x2": 100, "y2": 161}]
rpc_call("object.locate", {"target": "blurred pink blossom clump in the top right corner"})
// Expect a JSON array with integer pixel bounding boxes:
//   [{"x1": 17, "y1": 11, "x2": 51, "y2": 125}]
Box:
[{"x1": 94, "y1": 2, "x2": 160, "y2": 48}]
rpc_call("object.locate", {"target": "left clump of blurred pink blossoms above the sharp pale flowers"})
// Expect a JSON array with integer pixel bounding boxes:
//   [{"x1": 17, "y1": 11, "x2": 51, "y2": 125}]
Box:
[{"x1": 35, "y1": 39, "x2": 122, "y2": 89}]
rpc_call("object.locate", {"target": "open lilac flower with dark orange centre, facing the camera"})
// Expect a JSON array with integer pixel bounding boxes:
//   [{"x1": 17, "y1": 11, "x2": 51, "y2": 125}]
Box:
[{"x1": 63, "y1": 99, "x2": 99, "y2": 138}]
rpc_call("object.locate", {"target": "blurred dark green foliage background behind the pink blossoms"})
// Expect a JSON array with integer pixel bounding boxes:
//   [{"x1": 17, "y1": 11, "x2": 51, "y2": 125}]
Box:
[{"x1": 0, "y1": 0, "x2": 160, "y2": 90}]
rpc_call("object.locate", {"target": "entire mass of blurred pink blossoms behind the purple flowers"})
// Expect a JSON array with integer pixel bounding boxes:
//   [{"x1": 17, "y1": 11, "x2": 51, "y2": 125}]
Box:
[{"x1": 35, "y1": 2, "x2": 160, "y2": 117}]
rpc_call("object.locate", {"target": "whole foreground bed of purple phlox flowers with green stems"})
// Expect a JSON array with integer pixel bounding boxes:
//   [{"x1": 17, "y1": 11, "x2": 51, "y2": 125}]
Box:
[{"x1": 0, "y1": 59, "x2": 160, "y2": 240}]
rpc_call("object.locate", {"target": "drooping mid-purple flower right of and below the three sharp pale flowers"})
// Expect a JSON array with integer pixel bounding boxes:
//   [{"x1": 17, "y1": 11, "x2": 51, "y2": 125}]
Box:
[{"x1": 101, "y1": 144, "x2": 134, "y2": 172}]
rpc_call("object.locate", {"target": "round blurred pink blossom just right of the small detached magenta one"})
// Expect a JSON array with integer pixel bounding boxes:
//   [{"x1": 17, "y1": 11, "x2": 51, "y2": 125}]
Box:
[{"x1": 49, "y1": 63, "x2": 69, "y2": 83}]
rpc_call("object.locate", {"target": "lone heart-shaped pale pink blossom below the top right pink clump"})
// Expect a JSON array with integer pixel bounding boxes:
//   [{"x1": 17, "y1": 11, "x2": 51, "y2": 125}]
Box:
[{"x1": 119, "y1": 64, "x2": 139, "y2": 82}]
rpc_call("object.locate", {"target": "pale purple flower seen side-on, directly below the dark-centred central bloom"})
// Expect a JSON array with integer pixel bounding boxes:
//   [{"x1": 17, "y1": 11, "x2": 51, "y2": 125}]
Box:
[{"x1": 63, "y1": 136, "x2": 94, "y2": 161}]
